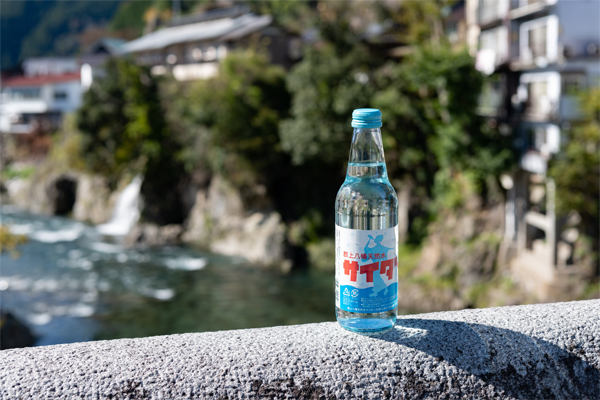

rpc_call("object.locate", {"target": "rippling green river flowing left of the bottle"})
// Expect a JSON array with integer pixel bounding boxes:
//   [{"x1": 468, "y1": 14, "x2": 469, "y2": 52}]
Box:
[{"x1": 0, "y1": 206, "x2": 335, "y2": 345}]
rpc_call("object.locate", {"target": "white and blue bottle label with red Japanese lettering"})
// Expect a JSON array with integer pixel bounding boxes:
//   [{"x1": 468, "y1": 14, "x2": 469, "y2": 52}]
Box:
[{"x1": 335, "y1": 225, "x2": 398, "y2": 313}]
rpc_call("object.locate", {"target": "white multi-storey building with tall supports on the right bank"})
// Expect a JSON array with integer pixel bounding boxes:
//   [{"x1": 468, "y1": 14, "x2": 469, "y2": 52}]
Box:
[{"x1": 467, "y1": 0, "x2": 600, "y2": 294}]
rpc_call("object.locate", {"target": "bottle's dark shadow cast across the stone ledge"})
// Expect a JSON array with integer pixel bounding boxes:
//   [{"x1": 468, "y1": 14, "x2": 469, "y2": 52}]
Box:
[{"x1": 375, "y1": 319, "x2": 600, "y2": 399}]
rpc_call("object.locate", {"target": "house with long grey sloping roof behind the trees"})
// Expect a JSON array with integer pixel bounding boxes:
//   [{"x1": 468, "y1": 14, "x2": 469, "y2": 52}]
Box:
[{"x1": 123, "y1": 6, "x2": 300, "y2": 81}]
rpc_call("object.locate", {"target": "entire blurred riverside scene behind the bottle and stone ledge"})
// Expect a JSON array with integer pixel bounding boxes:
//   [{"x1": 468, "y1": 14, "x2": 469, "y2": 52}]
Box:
[{"x1": 0, "y1": 0, "x2": 600, "y2": 348}]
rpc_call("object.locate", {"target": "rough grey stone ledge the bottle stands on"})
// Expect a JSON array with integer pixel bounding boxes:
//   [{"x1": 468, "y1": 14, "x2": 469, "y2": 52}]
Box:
[{"x1": 0, "y1": 300, "x2": 600, "y2": 399}]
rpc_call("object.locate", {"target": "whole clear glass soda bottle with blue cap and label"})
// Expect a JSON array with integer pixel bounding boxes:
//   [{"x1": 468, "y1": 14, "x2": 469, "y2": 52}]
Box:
[{"x1": 335, "y1": 108, "x2": 398, "y2": 334}]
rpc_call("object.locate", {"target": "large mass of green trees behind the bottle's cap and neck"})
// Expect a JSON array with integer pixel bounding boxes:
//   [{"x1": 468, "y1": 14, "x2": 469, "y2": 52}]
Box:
[{"x1": 279, "y1": 1, "x2": 515, "y2": 243}]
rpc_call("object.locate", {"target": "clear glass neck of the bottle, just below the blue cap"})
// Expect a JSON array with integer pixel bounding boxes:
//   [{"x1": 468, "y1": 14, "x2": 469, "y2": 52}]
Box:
[{"x1": 347, "y1": 128, "x2": 387, "y2": 178}]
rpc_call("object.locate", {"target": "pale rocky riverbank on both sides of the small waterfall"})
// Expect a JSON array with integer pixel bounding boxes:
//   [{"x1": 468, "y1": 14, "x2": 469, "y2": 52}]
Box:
[{"x1": 6, "y1": 172, "x2": 291, "y2": 271}]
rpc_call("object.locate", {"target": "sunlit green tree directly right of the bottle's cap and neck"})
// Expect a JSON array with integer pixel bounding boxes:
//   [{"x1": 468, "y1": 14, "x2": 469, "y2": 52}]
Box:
[{"x1": 373, "y1": 45, "x2": 514, "y2": 205}]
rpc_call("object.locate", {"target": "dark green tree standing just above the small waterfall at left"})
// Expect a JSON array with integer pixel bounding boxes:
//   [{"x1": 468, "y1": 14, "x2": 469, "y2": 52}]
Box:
[{"x1": 77, "y1": 59, "x2": 184, "y2": 224}]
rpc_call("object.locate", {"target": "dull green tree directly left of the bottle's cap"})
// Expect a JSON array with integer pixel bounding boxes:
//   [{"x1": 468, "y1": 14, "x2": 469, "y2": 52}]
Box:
[{"x1": 280, "y1": 44, "x2": 371, "y2": 164}]
